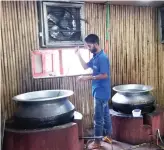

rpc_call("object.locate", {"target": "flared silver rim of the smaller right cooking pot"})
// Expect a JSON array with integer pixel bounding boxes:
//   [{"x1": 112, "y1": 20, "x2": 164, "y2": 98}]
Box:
[{"x1": 112, "y1": 84, "x2": 153, "y2": 94}]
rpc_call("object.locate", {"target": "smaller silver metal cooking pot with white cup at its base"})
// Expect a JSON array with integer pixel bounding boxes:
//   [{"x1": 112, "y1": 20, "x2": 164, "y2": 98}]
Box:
[{"x1": 112, "y1": 84, "x2": 155, "y2": 114}]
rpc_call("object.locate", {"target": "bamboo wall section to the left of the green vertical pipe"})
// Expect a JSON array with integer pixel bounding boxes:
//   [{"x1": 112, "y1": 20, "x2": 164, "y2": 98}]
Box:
[{"x1": 1, "y1": 1, "x2": 105, "y2": 127}]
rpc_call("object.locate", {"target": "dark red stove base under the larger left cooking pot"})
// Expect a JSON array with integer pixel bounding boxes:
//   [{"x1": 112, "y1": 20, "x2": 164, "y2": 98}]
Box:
[{"x1": 4, "y1": 112, "x2": 84, "y2": 150}]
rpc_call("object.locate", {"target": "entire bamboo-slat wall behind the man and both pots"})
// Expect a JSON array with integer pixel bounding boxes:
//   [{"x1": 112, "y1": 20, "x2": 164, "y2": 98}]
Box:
[{"x1": 1, "y1": 1, "x2": 164, "y2": 128}]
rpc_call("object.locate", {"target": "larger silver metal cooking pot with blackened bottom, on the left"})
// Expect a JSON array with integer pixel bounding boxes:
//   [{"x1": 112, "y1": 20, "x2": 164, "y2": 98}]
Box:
[{"x1": 13, "y1": 90, "x2": 75, "y2": 128}]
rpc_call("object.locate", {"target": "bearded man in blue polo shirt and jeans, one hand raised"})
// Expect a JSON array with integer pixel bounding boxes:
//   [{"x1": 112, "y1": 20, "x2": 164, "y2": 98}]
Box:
[{"x1": 76, "y1": 34, "x2": 112, "y2": 149}]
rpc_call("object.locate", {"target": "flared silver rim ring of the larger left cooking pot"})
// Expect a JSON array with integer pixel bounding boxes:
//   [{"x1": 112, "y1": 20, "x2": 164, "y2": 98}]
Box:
[{"x1": 12, "y1": 89, "x2": 74, "y2": 102}]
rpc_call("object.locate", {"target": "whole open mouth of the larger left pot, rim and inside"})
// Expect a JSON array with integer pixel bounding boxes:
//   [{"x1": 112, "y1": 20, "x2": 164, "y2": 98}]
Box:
[{"x1": 12, "y1": 90, "x2": 73, "y2": 102}]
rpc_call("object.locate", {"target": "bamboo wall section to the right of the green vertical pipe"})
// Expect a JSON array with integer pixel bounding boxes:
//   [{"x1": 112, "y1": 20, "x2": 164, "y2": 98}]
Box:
[{"x1": 109, "y1": 6, "x2": 164, "y2": 106}]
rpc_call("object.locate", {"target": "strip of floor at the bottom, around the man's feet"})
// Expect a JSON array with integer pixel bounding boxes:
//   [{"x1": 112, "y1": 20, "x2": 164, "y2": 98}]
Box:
[{"x1": 88, "y1": 141, "x2": 160, "y2": 150}]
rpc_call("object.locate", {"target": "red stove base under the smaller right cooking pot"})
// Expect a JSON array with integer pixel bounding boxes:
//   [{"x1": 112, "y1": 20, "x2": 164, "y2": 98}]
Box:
[{"x1": 110, "y1": 108, "x2": 164, "y2": 144}]
